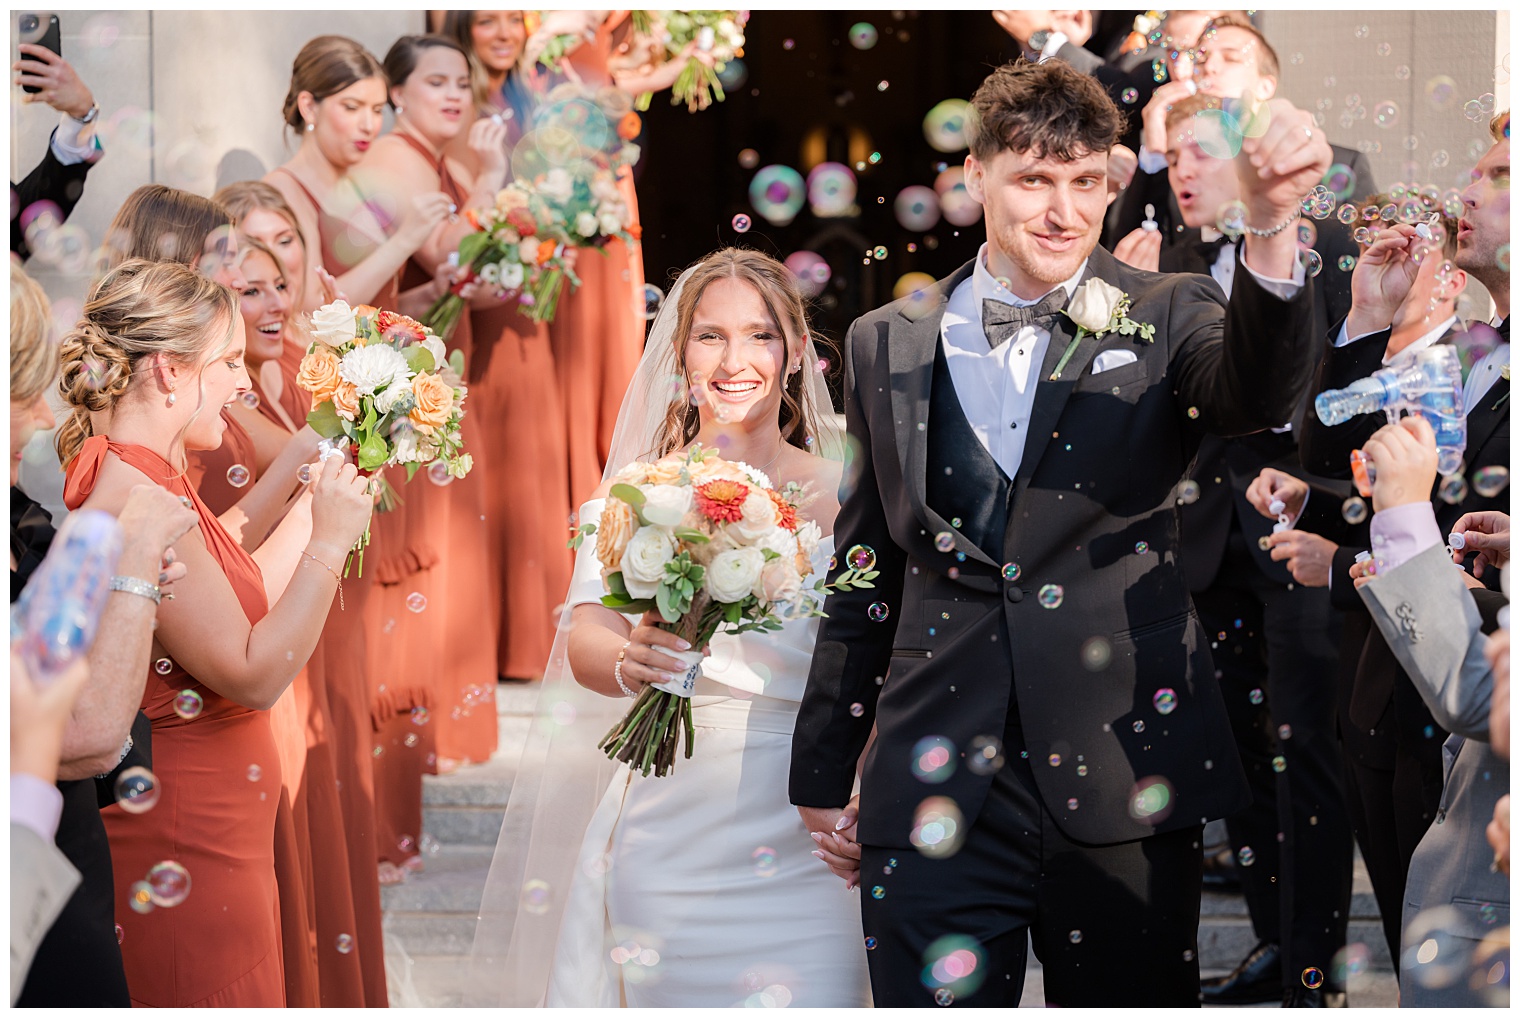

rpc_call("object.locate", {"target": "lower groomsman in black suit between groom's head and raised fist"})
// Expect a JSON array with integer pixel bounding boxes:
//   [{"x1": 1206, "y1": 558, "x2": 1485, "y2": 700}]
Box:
[{"x1": 1117, "y1": 96, "x2": 1357, "y2": 1006}]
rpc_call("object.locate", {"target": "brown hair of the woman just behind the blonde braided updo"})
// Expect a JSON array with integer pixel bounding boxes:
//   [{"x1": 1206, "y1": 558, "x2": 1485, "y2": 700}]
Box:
[{"x1": 106, "y1": 184, "x2": 233, "y2": 275}]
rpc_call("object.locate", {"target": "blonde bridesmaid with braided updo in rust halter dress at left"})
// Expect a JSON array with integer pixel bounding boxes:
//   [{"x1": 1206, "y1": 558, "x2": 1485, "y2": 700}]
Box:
[{"x1": 56, "y1": 260, "x2": 371, "y2": 1007}]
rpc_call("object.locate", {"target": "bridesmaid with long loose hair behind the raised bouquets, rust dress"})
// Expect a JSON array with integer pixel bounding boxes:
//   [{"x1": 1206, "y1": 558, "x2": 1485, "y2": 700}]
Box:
[{"x1": 444, "y1": 11, "x2": 577, "y2": 686}]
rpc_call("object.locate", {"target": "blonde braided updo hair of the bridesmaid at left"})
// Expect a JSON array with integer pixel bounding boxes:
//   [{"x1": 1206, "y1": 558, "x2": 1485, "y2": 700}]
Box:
[{"x1": 55, "y1": 258, "x2": 237, "y2": 466}]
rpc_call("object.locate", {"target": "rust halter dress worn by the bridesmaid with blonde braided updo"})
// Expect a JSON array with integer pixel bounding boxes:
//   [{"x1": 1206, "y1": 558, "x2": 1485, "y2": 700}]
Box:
[{"x1": 64, "y1": 435, "x2": 286, "y2": 1007}]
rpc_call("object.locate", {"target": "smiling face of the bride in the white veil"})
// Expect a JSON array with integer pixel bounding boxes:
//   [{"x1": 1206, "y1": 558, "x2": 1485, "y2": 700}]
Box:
[{"x1": 686, "y1": 277, "x2": 787, "y2": 425}]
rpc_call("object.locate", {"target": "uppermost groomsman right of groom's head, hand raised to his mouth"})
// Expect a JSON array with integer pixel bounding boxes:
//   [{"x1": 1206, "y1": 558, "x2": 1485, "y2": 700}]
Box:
[{"x1": 1113, "y1": 12, "x2": 1377, "y2": 249}]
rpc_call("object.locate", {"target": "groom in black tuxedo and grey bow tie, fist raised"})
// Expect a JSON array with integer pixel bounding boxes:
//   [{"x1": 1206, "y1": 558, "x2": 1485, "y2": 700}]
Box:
[{"x1": 790, "y1": 61, "x2": 1330, "y2": 1007}]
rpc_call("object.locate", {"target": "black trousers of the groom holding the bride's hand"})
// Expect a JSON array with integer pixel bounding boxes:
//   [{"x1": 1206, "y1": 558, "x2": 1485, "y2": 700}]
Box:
[{"x1": 860, "y1": 720, "x2": 1202, "y2": 1007}]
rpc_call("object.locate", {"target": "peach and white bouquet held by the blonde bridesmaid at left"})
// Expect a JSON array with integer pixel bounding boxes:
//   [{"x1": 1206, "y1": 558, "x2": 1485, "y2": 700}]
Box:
[{"x1": 296, "y1": 301, "x2": 473, "y2": 574}]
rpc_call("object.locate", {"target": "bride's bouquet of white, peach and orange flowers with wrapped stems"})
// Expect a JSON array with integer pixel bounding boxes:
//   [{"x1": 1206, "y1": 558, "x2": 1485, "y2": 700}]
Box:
[{"x1": 572, "y1": 445, "x2": 877, "y2": 778}]
